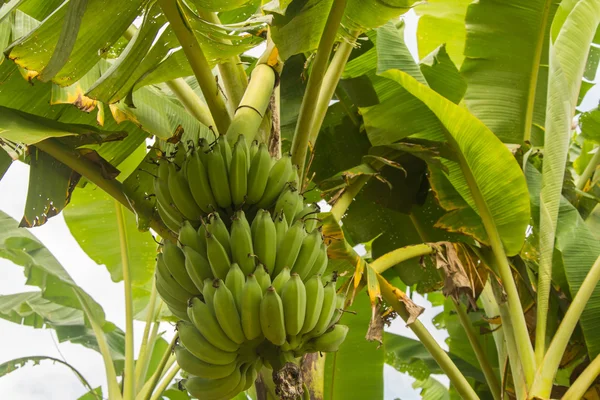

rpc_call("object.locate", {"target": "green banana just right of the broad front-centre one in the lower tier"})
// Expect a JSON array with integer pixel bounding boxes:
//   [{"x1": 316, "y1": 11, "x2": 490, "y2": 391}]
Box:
[{"x1": 281, "y1": 273, "x2": 306, "y2": 336}]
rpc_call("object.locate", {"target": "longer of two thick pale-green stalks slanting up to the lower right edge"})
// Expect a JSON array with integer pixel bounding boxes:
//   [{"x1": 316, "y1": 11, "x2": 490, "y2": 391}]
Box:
[{"x1": 530, "y1": 256, "x2": 600, "y2": 398}]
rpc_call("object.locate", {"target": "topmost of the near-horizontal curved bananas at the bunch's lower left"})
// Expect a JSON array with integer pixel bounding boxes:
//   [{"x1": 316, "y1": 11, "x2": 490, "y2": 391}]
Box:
[{"x1": 177, "y1": 321, "x2": 237, "y2": 365}]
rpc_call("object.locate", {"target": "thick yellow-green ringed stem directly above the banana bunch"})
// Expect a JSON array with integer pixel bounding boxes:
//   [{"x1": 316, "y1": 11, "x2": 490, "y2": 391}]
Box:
[{"x1": 227, "y1": 64, "x2": 275, "y2": 142}]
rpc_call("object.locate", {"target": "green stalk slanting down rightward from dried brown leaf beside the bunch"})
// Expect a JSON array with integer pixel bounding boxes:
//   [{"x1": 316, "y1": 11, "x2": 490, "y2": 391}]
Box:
[{"x1": 377, "y1": 274, "x2": 479, "y2": 400}]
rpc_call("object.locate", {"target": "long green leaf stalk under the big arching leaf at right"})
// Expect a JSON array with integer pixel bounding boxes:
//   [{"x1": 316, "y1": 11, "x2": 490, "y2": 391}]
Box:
[{"x1": 446, "y1": 135, "x2": 536, "y2": 385}]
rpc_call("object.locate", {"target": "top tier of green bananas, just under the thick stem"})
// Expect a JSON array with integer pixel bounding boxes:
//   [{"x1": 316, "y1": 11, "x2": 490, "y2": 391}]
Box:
[{"x1": 154, "y1": 135, "x2": 302, "y2": 232}]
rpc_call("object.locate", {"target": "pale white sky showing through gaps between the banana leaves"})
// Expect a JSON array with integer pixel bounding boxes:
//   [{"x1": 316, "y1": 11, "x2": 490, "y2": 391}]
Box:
[{"x1": 0, "y1": 7, "x2": 600, "y2": 400}]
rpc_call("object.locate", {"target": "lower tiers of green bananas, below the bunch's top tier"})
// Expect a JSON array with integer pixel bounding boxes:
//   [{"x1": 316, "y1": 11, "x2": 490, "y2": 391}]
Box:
[{"x1": 155, "y1": 206, "x2": 348, "y2": 400}]
